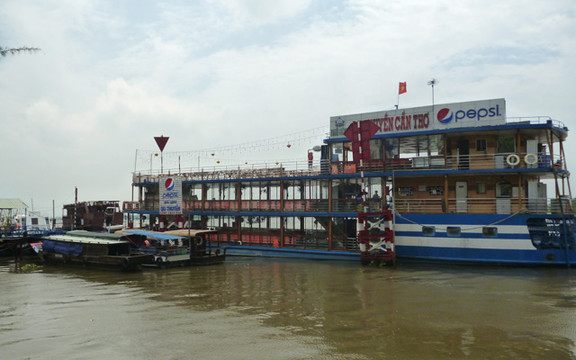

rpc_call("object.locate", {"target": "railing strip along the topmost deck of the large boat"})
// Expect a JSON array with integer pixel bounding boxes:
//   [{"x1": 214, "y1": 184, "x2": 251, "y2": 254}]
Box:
[{"x1": 132, "y1": 149, "x2": 566, "y2": 186}]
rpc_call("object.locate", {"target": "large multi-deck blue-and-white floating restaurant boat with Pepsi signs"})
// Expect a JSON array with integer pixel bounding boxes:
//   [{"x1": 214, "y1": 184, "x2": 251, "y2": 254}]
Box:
[{"x1": 124, "y1": 99, "x2": 576, "y2": 266}]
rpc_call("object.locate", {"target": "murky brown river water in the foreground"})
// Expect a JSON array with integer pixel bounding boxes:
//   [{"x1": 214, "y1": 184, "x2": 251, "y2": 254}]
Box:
[{"x1": 0, "y1": 257, "x2": 576, "y2": 360}]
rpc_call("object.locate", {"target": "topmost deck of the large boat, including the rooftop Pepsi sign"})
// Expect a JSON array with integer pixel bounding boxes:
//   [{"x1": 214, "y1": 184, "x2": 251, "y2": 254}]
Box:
[{"x1": 133, "y1": 99, "x2": 568, "y2": 186}]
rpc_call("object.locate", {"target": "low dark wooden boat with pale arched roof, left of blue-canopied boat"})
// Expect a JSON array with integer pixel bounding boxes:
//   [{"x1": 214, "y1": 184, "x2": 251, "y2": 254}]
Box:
[{"x1": 32, "y1": 230, "x2": 154, "y2": 271}]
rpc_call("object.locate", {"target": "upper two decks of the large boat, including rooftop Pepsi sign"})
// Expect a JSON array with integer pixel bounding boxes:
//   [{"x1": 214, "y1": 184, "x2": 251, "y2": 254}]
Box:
[{"x1": 133, "y1": 99, "x2": 569, "y2": 215}]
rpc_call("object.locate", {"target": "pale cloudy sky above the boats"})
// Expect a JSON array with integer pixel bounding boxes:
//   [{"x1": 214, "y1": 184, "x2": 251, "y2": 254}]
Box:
[{"x1": 0, "y1": 0, "x2": 576, "y2": 216}]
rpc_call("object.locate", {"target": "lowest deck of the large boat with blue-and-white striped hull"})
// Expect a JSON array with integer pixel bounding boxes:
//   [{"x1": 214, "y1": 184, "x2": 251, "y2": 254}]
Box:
[{"x1": 127, "y1": 213, "x2": 576, "y2": 265}]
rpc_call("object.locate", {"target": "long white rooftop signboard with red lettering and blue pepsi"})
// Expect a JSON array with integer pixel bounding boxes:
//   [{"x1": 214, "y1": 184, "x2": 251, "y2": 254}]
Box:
[{"x1": 330, "y1": 99, "x2": 506, "y2": 137}]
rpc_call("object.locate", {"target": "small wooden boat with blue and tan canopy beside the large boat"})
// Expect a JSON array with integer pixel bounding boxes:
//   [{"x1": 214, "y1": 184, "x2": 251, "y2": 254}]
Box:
[{"x1": 120, "y1": 229, "x2": 226, "y2": 268}]
